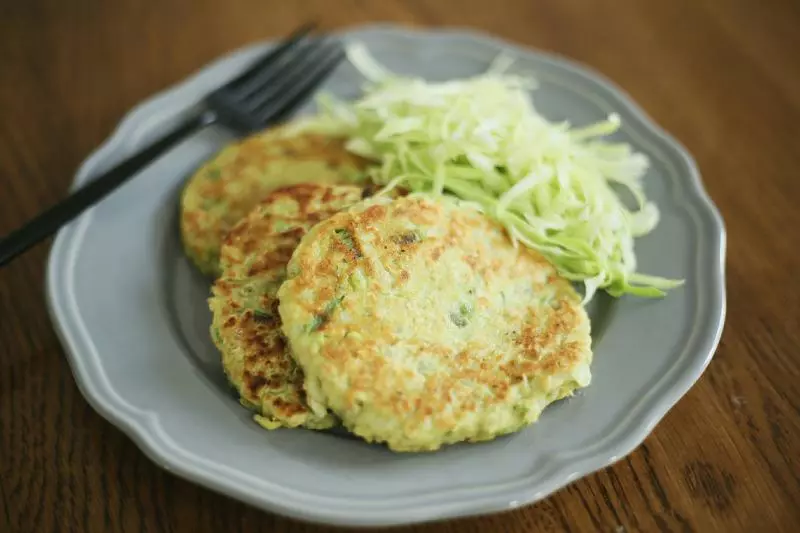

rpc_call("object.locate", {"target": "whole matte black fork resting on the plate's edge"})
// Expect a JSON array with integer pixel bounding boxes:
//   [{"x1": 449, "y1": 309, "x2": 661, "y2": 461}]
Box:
[{"x1": 0, "y1": 25, "x2": 344, "y2": 267}]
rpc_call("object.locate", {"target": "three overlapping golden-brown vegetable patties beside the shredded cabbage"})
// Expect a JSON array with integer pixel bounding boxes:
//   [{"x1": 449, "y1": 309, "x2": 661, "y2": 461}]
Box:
[{"x1": 181, "y1": 122, "x2": 592, "y2": 451}]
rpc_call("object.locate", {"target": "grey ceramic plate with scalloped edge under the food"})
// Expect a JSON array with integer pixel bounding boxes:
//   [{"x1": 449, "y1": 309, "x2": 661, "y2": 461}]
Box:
[{"x1": 47, "y1": 26, "x2": 725, "y2": 525}]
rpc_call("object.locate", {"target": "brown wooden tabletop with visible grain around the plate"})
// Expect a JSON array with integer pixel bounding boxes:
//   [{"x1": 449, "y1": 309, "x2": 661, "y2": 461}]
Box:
[{"x1": 0, "y1": 0, "x2": 800, "y2": 533}]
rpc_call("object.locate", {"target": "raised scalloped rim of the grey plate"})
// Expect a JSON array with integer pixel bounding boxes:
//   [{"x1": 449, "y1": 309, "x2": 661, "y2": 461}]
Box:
[{"x1": 47, "y1": 24, "x2": 726, "y2": 526}]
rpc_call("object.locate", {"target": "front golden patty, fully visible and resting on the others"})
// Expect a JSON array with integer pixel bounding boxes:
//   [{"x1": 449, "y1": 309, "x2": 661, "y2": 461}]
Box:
[{"x1": 278, "y1": 195, "x2": 592, "y2": 451}]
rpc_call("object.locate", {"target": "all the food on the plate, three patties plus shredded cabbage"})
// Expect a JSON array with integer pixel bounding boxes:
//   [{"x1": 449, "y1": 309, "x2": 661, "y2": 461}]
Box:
[{"x1": 181, "y1": 44, "x2": 682, "y2": 452}]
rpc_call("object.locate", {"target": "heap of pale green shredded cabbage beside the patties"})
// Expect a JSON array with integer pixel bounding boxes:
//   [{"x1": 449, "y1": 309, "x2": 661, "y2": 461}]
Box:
[{"x1": 306, "y1": 42, "x2": 682, "y2": 302}]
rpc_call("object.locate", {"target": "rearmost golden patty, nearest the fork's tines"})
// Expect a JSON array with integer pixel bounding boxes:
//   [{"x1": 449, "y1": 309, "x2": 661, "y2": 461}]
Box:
[{"x1": 180, "y1": 124, "x2": 367, "y2": 276}]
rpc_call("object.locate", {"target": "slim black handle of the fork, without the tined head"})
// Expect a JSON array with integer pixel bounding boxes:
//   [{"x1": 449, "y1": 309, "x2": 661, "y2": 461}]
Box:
[{"x1": 0, "y1": 113, "x2": 215, "y2": 267}]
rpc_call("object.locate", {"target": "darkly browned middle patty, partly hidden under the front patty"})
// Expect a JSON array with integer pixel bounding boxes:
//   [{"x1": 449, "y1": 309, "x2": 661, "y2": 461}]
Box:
[{"x1": 209, "y1": 184, "x2": 376, "y2": 429}]
